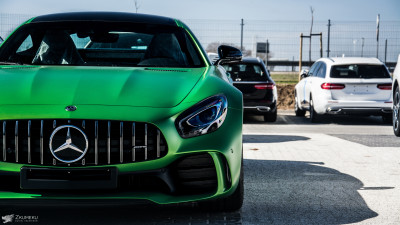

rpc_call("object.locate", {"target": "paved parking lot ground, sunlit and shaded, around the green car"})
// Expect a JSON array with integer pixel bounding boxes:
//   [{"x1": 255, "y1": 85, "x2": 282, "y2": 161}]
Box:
[{"x1": 0, "y1": 112, "x2": 400, "y2": 225}]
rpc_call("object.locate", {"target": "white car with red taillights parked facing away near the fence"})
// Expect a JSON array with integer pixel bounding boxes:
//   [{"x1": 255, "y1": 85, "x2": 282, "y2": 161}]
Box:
[{"x1": 294, "y1": 57, "x2": 392, "y2": 122}]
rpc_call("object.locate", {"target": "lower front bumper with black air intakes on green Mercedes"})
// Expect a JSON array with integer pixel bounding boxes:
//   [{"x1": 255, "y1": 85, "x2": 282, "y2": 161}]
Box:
[{"x1": 0, "y1": 152, "x2": 236, "y2": 204}]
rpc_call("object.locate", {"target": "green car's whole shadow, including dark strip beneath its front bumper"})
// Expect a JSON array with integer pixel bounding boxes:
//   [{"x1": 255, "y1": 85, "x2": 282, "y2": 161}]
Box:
[{"x1": 0, "y1": 159, "x2": 378, "y2": 225}]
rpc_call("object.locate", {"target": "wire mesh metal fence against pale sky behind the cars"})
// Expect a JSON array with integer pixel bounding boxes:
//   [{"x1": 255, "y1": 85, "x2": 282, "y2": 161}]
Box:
[{"x1": 0, "y1": 14, "x2": 400, "y2": 70}]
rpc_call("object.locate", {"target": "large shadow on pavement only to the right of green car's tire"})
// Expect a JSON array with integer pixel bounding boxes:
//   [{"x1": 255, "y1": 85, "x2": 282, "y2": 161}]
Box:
[{"x1": 242, "y1": 160, "x2": 378, "y2": 224}]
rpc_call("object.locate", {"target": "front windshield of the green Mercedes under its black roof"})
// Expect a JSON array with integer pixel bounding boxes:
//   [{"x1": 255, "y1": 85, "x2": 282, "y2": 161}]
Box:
[{"x1": 0, "y1": 21, "x2": 204, "y2": 68}]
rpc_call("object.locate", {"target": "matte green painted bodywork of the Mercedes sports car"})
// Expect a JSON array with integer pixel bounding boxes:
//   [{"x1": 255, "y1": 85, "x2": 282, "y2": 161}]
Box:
[{"x1": 0, "y1": 18, "x2": 243, "y2": 204}]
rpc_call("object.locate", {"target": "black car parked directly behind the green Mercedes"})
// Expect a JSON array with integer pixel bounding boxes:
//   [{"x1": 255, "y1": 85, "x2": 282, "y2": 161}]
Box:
[{"x1": 222, "y1": 58, "x2": 278, "y2": 122}]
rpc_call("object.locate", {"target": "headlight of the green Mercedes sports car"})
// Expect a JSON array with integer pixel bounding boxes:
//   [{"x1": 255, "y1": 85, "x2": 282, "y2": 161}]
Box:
[{"x1": 175, "y1": 95, "x2": 228, "y2": 138}]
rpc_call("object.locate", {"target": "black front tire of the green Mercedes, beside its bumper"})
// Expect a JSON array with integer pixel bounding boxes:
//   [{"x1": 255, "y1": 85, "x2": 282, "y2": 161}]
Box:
[{"x1": 199, "y1": 153, "x2": 244, "y2": 212}]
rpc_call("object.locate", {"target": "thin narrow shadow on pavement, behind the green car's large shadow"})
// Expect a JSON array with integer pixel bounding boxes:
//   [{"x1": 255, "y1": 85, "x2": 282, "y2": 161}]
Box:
[{"x1": 243, "y1": 134, "x2": 310, "y2": 143}]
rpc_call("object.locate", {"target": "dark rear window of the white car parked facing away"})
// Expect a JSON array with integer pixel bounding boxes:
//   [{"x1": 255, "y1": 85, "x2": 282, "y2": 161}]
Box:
[{"x1": 331, "y1": 64, "x2": 390, "y2": 79}]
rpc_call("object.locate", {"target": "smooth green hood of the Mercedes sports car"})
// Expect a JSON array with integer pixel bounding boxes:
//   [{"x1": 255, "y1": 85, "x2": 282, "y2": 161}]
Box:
[{"x1": 0, "y1": 66, "x2": 205, "y2": 108}]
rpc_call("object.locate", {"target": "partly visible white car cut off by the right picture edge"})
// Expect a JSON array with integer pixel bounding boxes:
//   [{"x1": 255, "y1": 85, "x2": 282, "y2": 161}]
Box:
[{"x1": 392, "y1": 55, "x2": 400, "y2": 137}]
